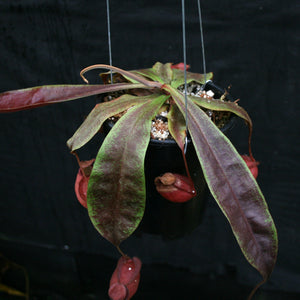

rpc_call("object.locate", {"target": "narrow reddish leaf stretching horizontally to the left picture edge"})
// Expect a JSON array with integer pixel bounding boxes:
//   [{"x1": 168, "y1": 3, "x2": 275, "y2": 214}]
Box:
[{"x1": 0, "y1": 83, "x2": 147, "y2": 112}]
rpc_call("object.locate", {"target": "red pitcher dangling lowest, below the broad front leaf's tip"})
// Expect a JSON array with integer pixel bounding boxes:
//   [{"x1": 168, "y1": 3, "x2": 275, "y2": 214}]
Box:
[{"x1": 108, "y1": 256, "x2": 142, "y2": 300}]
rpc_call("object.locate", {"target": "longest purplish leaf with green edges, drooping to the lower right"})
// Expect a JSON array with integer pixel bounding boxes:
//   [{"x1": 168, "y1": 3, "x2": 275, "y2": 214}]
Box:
[{"x1": 165, "y1": 87, "x2": 278, "y2": 280}]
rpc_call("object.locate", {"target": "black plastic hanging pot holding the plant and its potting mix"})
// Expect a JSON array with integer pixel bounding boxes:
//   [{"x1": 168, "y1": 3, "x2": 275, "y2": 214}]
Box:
[{"x1": 104, "y1": 81, "x2": 235, "y2": 239}]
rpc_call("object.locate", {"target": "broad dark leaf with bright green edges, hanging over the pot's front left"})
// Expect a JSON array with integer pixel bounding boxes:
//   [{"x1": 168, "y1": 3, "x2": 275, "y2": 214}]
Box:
[{"x1": 87, "y1": 95, "x2": 169, "y2": 246}]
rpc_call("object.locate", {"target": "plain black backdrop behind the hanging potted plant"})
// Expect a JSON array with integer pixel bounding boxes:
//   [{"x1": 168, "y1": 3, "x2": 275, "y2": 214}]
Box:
[{"x1": 0, "y1": 0, "x2": 300, "y2": 299}]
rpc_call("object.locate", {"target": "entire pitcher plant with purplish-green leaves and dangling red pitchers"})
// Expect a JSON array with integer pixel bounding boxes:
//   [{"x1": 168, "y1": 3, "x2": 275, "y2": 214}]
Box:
[{"x1": 0, "y1": 63, "x2": 278, "y2": 299}]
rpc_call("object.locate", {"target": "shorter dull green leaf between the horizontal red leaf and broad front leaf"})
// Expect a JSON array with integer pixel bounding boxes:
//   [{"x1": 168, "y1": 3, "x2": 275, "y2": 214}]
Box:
[{"x1": 67, "y1": 94, "x2": 163, "y2": 151}]
